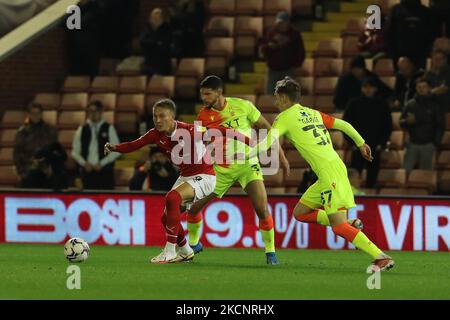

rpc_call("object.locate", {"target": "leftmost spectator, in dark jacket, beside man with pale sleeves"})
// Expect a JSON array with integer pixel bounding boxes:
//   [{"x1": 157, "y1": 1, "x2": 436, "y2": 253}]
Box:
[{"x1": 13, "y1": 102, "x2": 57, "y2": 185}]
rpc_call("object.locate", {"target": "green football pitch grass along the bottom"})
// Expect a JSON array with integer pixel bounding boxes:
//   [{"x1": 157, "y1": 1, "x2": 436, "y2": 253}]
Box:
[{"x1": 0, "y1": 244, "x2": 450, "y2": 300}]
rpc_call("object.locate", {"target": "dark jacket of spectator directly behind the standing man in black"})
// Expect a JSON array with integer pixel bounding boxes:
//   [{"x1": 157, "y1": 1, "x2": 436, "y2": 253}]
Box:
[{"x1": 333, "y1": 70, "x2": 392, "y2": 110}]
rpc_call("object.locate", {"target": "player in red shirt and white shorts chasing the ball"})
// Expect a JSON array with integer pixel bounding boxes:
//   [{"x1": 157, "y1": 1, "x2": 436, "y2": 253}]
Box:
[{"x1": 105, "y1": 99, "x2": 250, "y2": 263}]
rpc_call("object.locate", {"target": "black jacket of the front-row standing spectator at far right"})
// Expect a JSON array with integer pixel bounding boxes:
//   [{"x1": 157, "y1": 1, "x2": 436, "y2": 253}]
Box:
[{"x1": 400, "y1": 95, "x2": 445, "y2": 146}]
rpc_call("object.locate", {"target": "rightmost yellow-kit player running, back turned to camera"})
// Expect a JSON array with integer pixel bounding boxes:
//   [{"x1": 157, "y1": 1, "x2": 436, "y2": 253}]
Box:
[{"x1": 248, "y1": 77, "x2": 394, "y2": 271}]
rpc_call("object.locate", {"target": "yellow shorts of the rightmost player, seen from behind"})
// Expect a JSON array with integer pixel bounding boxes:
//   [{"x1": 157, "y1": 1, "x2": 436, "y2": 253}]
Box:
[{"x1": 300, "y1": 160, "x2": 356, "y2": 214}]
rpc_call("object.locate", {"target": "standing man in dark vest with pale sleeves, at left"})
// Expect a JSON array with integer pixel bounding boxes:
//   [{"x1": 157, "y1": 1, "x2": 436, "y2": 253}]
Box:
[{"x1": 72, "y1": 101, "x2": 120, "y2": 190}]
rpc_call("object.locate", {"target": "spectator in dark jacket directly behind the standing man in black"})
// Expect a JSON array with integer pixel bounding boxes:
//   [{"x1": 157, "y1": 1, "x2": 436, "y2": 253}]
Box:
[{"x1": 333, "y1": 56, "x2": 392, "y2": 111}]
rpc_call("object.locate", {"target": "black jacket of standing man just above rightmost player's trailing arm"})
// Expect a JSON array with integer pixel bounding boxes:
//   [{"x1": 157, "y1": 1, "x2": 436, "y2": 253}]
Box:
[{"x1": 343, "y1": 95, "x2": 392, "y2": 147}]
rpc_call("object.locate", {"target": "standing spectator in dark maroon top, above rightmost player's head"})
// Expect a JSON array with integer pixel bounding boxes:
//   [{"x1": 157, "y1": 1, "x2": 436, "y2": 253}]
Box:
[{"x1": 261, "y1": 12, "x2": 306, "y2": 94}]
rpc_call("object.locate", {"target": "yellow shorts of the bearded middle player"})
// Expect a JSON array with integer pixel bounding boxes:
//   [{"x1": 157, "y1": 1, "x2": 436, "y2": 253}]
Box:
[{"x1": 214, "y1": 163, "x2": 264, "y2": 198}]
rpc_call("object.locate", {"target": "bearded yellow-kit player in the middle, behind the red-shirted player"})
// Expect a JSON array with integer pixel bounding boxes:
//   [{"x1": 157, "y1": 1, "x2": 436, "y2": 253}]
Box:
[{"x1": 187, "y1": 76, "x2": 289, "y2": 264}]
